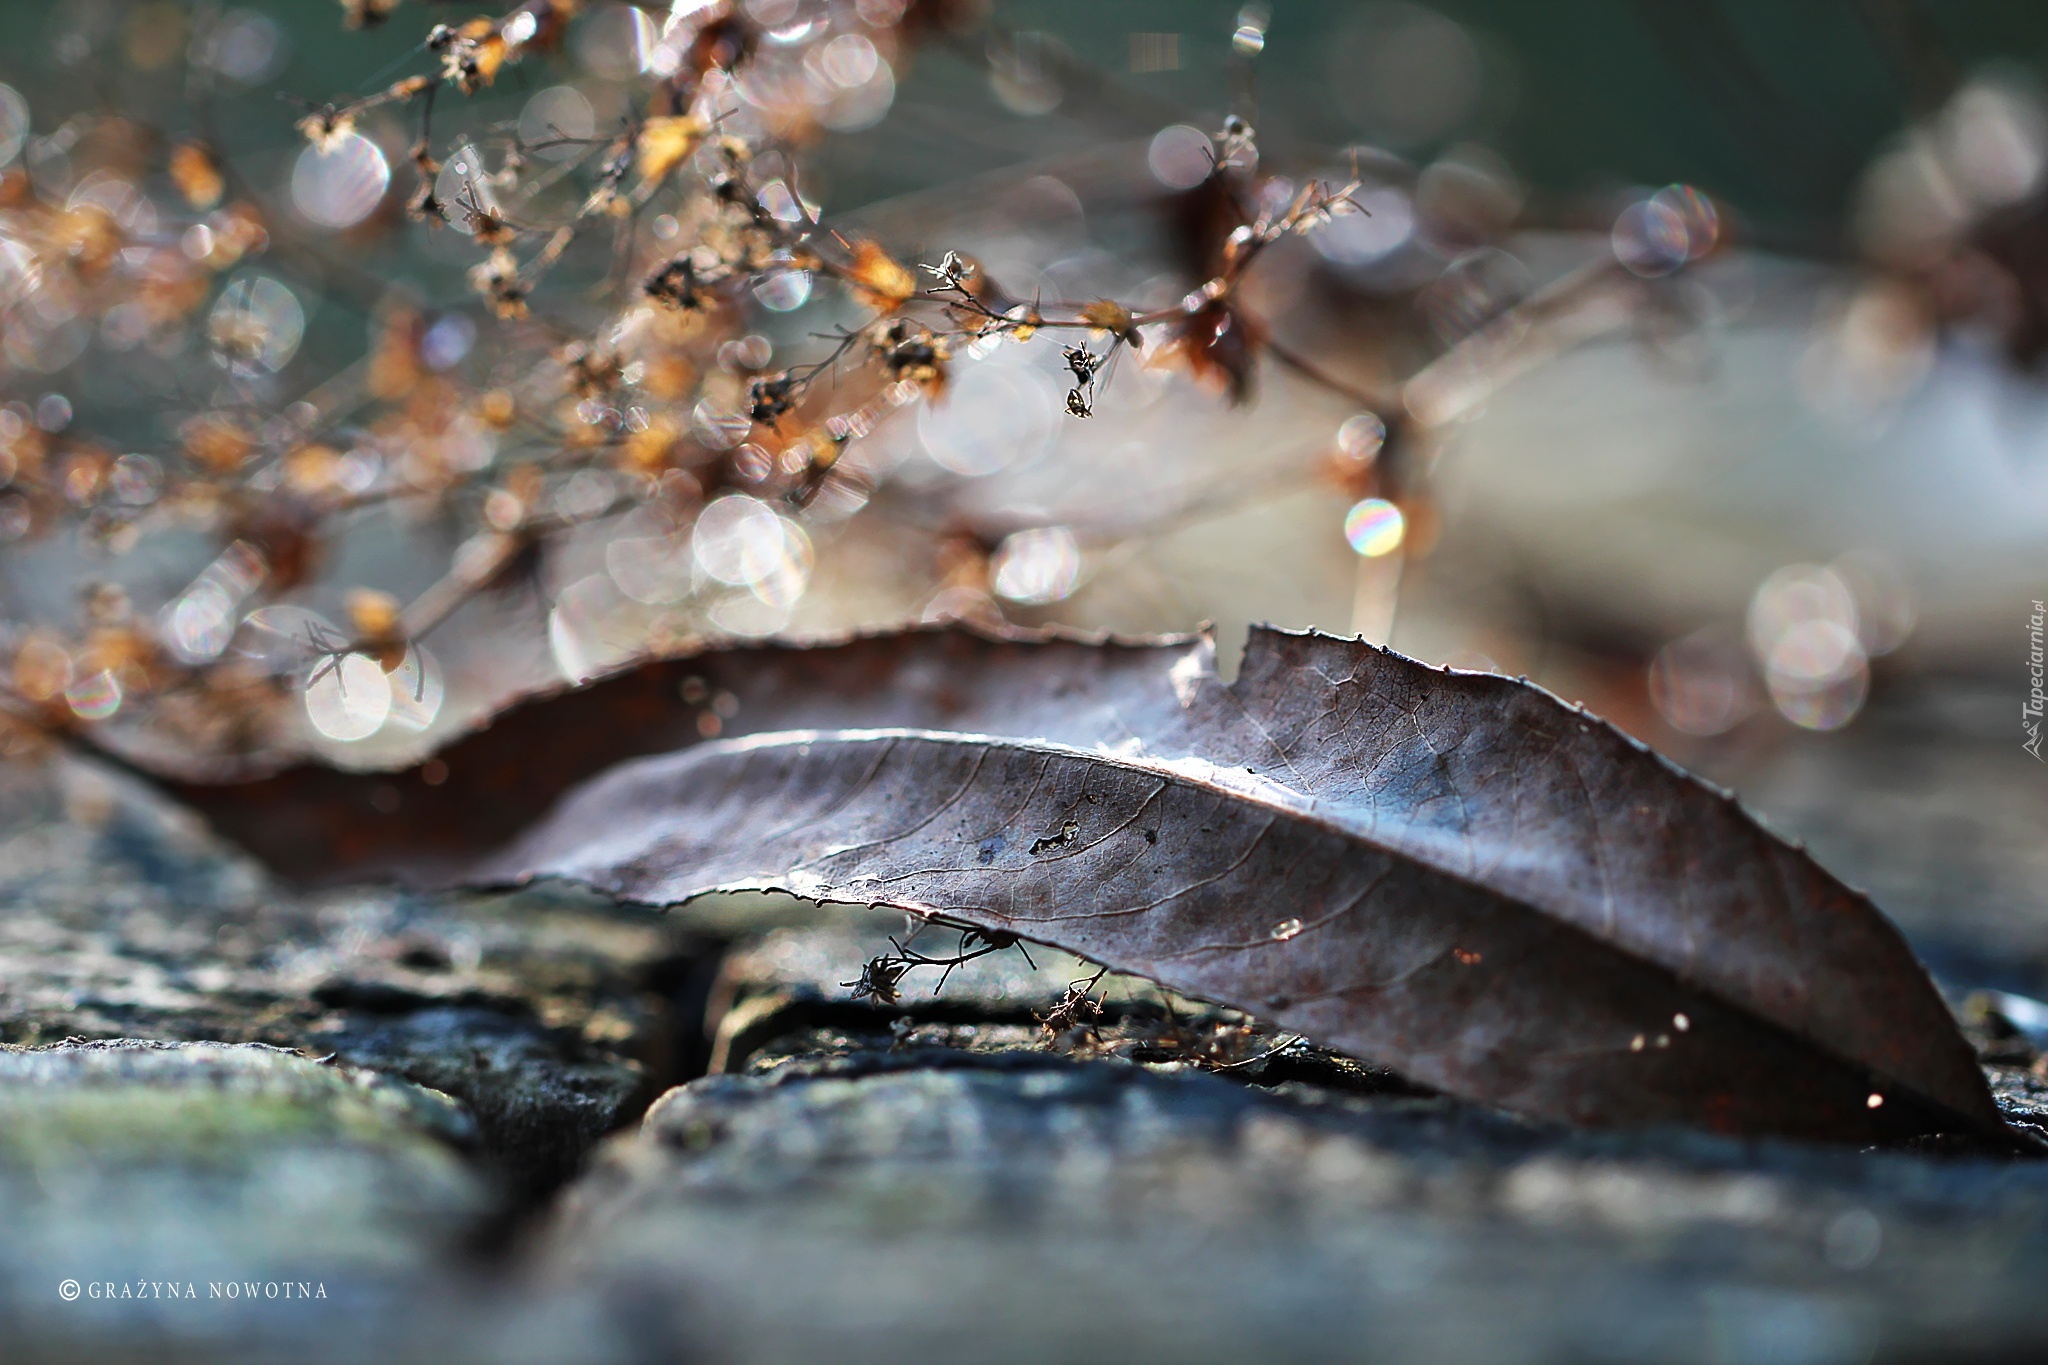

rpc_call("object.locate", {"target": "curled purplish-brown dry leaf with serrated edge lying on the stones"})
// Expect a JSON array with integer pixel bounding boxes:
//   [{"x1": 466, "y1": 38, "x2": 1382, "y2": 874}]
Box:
[{"x1": 132, "y1": 628, "x2": 2003, "y2": 1142}]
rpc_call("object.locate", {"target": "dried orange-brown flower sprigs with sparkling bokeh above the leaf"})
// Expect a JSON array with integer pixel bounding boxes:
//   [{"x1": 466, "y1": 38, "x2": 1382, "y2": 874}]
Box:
[{"x1": 0, "y1": 0, "x2": 1703, "y2": 761}]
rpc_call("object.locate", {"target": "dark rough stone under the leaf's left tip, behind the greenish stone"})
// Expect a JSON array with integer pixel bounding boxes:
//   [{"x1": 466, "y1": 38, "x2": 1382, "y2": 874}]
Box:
[{"x1": 0, "y1": 763, "x2": 713, "y2": 1195}]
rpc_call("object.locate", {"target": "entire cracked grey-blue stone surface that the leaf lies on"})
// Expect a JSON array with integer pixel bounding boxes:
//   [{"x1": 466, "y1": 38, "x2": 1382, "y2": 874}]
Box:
[{"x1": 0, "y1": 753, "x2": 2048, "y2": 1363}]
